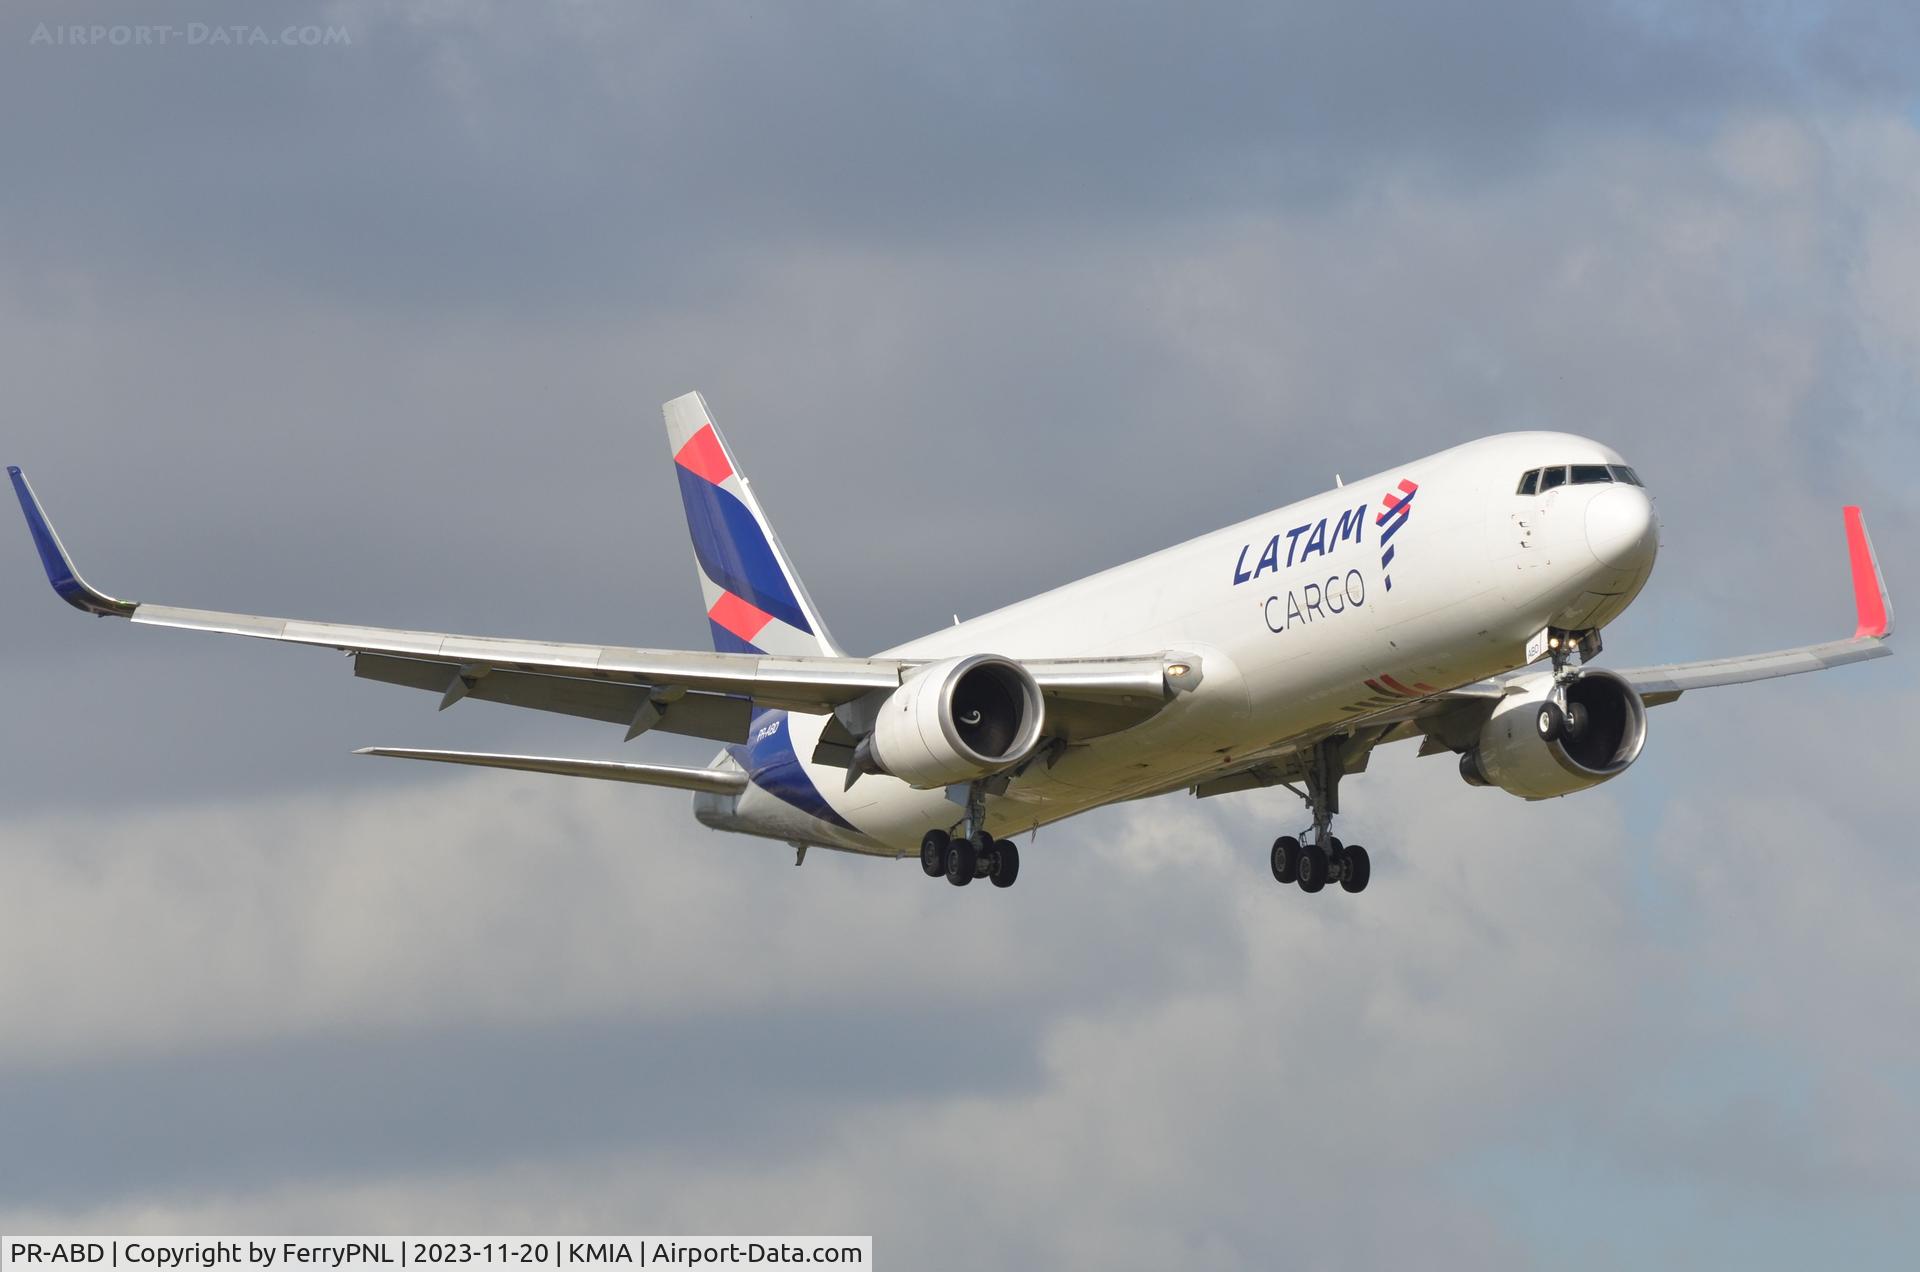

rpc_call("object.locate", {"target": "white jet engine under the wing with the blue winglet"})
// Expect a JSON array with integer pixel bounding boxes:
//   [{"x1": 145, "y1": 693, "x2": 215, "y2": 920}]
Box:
[{"x1": 868, "y1": 653, "x2": 1046, "y2": 790}]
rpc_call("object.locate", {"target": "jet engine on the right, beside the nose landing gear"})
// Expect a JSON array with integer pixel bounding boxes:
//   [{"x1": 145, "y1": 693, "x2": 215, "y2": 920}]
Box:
[{"x1": 1459, "y1": 667, "x2": 1647, "y2": 799}]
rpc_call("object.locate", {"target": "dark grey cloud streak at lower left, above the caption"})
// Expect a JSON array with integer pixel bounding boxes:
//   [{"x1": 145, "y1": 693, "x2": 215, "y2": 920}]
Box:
[{"x1": 0, "y1": 1006, "x2": 1037, "y2": 1207}]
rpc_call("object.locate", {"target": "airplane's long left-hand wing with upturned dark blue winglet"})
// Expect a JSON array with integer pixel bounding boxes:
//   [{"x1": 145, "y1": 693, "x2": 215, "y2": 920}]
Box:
[{"x1": 8, "y1": 467, "x2": 1192, "y2": 742}]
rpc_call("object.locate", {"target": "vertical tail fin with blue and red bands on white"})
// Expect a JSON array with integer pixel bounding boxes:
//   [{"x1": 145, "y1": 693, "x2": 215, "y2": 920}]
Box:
[{"x1": 664, "y1": 394, "x2": 841, "y2": 655}]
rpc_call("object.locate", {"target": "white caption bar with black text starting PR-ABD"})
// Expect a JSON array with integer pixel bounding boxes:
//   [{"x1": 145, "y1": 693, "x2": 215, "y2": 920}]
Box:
[{"x1": 0, "y1": 1235, "x2": 874, "y2": 1272}]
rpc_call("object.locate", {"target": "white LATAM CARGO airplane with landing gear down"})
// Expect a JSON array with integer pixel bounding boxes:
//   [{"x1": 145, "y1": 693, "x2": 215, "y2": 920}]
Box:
[{"x1": 8, "y1": 392, "x2": 1893, "y2": 893}]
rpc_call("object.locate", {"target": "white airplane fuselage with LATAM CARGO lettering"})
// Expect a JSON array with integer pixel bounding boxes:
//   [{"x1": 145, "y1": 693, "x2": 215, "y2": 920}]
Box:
[{"x1": 695, "y1": 432, "x2": 1657, "y2": 855}]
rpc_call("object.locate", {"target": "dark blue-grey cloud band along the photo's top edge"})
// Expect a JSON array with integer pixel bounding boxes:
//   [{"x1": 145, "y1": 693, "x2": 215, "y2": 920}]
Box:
[{"x1": 0, "y1": 2, "x2": 1914, "y2": 311}]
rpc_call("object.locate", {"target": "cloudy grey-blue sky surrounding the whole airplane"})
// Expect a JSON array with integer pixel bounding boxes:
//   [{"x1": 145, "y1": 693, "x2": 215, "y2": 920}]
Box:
[{"x1": 0, "y1": 0, "x2": 1920, "y2": 1268}]
